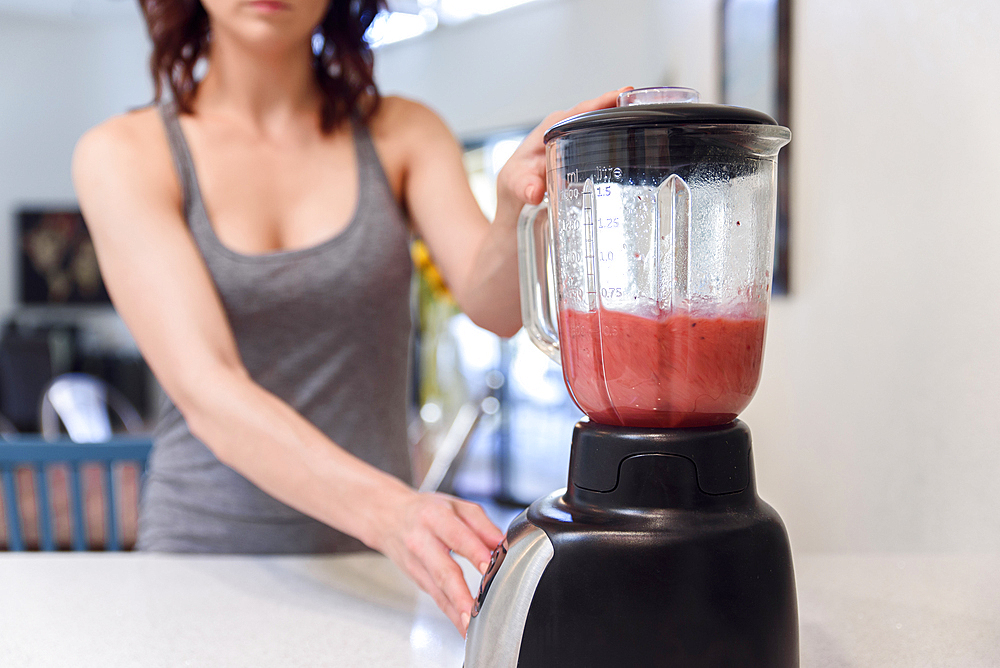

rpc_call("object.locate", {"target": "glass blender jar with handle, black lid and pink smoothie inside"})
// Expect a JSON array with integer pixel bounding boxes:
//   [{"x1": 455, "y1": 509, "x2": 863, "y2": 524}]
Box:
[{"x1": 519, "y1": 88, "x2": 791, "y2": 428}]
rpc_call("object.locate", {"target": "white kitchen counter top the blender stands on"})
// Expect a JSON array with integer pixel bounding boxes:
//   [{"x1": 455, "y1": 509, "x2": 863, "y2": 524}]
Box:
[{"x1": 0, "y1": 553, "x2": 1000, "y2": 668}]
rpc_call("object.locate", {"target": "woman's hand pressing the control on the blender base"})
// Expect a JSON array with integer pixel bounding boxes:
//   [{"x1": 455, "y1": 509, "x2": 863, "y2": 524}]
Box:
[{"x1": 371, "y1": 488, "x2": 503, "y2": 636}]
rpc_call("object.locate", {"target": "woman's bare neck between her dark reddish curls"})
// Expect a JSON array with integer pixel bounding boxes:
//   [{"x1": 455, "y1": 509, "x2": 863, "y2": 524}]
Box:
[{"x1": 195, "y1": 26, "x2": 322, "y2": 134}]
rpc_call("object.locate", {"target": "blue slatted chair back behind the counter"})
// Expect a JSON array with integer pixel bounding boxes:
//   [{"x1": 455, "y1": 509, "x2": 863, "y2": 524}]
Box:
[{"x1": 0, "y1": 435, "x2": 153, "y2": 551}]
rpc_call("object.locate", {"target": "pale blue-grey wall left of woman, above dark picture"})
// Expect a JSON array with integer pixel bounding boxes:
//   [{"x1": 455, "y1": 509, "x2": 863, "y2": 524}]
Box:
[{"x1": 0, "y1": 10, "x2": 152, "y2": 319}]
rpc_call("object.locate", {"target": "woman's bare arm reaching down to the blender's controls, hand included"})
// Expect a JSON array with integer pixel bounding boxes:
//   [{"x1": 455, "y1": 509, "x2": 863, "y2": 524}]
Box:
[{"x1": 73, "y1": 110, "x2": 503, "y2": 631}]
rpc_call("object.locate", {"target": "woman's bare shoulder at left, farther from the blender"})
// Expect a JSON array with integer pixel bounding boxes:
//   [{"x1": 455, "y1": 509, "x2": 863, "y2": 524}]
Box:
[{"x1": 73, "y1": 105, "x2": 179, "y2": 204}]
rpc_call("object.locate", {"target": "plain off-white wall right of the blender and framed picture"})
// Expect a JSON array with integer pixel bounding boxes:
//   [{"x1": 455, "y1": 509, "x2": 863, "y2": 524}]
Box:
[{"x1": 745, "y1": 0, "x2": 1000, "y2": 550}]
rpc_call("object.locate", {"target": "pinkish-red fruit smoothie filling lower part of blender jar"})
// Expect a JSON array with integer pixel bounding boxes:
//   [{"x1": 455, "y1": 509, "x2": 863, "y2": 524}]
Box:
[{"x1": 559, "y1": 308, "x2": 765, "y2": 428}]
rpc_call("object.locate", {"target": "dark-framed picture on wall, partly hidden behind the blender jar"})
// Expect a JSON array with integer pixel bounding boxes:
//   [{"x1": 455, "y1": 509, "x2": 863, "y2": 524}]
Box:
[{"x1": 719, "y1": 0, "x2": 792, "y2": 295}]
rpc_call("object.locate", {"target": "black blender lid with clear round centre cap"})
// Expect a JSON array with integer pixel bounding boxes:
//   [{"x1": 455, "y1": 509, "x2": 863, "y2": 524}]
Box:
[{"x1": 545, "y1": 87, "x2": 778, "y2": 143}]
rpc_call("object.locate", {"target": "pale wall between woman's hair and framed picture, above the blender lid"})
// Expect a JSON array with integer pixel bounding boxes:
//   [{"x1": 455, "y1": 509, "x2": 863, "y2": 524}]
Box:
[{"x1": 375, "y1": 0, "x2": 718, "y2": 138}]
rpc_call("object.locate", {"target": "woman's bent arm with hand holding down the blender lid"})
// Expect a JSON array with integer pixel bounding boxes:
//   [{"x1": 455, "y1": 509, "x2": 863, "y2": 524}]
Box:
[{"x1": 400, "y1": 88, "x2": 626, "y2": 336}]
